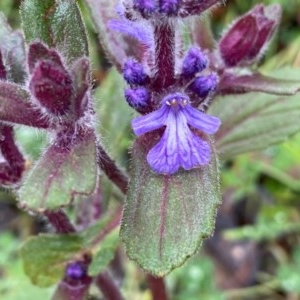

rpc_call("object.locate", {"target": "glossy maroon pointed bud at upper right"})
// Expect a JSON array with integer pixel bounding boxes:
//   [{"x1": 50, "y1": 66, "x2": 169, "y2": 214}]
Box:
[{"x1": 219, "y1": 4, "x2": 281, "y2": 67}]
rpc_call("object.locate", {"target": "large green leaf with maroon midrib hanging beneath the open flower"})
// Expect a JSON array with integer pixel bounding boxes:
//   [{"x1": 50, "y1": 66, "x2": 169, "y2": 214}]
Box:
[{"x1": 120, "y1": 136, "x2": 221, "y2": 276}]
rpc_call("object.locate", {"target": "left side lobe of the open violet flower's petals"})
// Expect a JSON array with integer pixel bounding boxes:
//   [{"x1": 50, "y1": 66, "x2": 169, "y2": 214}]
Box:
[{"x1": 131, "y1": 105, "x2": 170, "y2": 136}]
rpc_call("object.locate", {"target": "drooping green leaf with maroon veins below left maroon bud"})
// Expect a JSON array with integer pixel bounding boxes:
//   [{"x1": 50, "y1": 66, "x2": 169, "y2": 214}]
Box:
[{"x1": 19, "y1": 132, "x2": 97, "y2": 211}]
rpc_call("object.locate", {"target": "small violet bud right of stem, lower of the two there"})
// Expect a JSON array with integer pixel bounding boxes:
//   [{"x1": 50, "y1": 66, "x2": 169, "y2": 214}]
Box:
[{"x1": 190, "y1": 74, "x2": 218, "y2": 98}]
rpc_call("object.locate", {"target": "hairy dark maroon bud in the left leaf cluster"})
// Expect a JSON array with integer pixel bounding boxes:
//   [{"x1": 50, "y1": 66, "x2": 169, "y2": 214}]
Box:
[{"x1": 29, "y1": 61, "x2": 72, "y2": 115}]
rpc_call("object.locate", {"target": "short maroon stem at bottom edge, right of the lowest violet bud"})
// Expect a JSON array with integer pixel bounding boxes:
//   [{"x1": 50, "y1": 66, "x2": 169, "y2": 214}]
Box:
[{"x1": 95, "y1": 272, "x2": 124, "y2": 300}]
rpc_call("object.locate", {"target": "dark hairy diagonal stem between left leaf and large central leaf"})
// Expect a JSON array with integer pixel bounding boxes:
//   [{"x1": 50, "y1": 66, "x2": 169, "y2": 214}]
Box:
[{"x1": 97, "y1": 144, "x2": 128, "y2": 195}]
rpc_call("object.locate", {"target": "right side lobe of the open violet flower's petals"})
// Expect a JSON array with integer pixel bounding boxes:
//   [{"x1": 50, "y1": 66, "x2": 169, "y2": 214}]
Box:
[{"x1": 183, "y1": 105, "x2": 221, "y2": 134}]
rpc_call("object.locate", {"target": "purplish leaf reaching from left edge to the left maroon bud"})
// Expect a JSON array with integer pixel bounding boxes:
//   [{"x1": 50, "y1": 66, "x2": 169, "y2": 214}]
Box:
[{"x1": 0, "y1": 81, "x2": 50, "y2": 128}]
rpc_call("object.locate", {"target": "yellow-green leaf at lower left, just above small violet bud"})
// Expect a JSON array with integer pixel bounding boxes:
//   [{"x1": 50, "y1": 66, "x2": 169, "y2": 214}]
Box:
[{"x1": 21, "y1": 215, "x2": 118, "y2": 287}]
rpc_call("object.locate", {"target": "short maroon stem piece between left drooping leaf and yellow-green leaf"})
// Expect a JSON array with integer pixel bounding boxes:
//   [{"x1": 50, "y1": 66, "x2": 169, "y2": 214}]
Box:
[{"x1": 44, "y1": 209, "x2": 76, "y2": 234}]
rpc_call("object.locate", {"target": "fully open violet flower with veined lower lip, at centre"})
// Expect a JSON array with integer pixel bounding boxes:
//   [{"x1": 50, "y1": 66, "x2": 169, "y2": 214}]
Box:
[{"x1": 132, "y1": 93, "x2": 220, "y2": 174}]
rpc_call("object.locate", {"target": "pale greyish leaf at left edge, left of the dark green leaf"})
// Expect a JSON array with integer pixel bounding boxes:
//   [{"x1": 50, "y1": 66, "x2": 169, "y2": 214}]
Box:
[{"x1": 0, "y1": 12, "x2": 26, "y2": 83}]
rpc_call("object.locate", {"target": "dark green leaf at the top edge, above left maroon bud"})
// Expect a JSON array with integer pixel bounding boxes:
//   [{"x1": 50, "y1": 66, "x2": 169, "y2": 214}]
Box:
[{"x1": 21, "y1": 0, "x2": 88, "y2": 65}]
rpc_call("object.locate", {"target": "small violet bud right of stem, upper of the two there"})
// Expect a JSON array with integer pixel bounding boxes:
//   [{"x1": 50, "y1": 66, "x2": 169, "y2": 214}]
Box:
[{"x1": 182, "y1": 47, "x2": 207, "y2": 76}]
